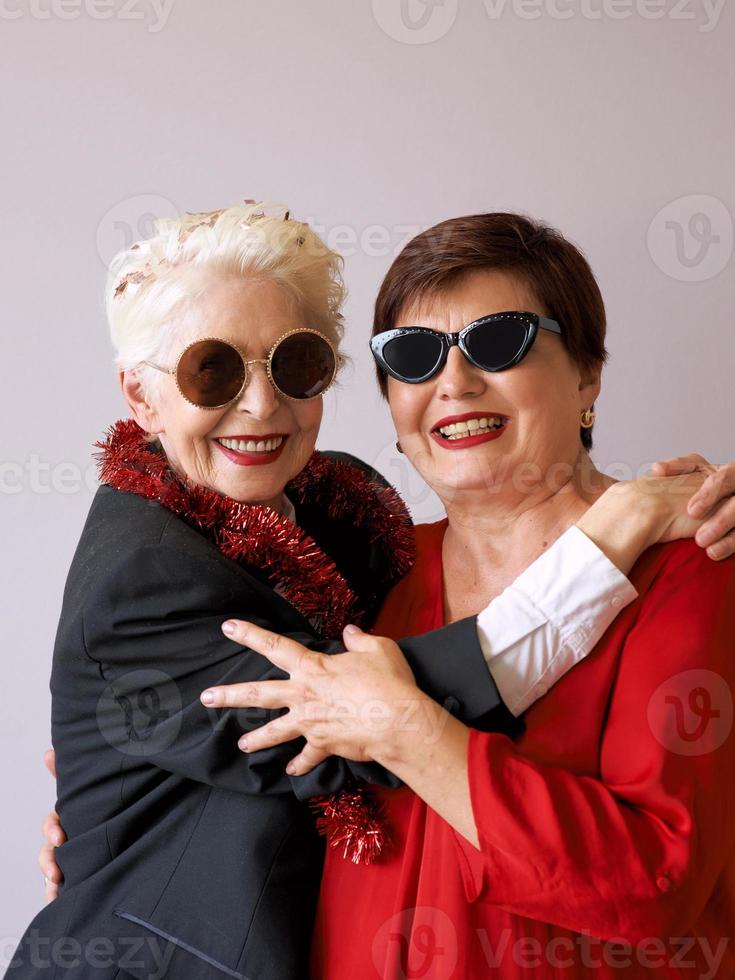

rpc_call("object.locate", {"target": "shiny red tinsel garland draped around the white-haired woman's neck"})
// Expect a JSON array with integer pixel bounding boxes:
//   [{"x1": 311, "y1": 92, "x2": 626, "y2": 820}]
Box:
[{"x1": 95, "y1": 419, "x2": 415, "y2": 864}]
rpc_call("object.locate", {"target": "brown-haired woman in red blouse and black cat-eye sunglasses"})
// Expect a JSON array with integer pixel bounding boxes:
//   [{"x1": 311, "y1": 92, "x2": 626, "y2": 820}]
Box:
[{"x1": 208, "y1": 214, "x2": 735, "y2": 980}]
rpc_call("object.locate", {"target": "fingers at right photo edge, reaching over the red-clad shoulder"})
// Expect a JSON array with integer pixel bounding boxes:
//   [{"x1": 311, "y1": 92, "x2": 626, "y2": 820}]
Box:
[{"x1": 651, "y1": 453, "x2": 735, "y2": 561}]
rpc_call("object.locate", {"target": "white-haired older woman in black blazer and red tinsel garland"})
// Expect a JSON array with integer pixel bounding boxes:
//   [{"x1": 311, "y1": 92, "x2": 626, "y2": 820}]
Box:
[{"x1": 23, "y1": 204, "x2": 735, "y2": 980}]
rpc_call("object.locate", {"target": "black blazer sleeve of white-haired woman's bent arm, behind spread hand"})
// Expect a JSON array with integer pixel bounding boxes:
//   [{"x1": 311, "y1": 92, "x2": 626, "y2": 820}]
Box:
[{"x1": 83, "y1": 539, "x2": 515, "y2": 799}]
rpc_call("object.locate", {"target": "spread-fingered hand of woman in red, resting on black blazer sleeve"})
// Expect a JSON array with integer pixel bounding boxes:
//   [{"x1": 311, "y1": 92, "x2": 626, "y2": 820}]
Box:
[{"x1": 202, "y1": 620, "x2": 426, "y2": 775}]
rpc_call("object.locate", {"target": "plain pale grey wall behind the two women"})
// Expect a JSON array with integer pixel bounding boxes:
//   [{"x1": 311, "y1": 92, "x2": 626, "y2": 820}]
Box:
[{"x1": 0, "y1": 0, "x2": 735, "y2": 965}]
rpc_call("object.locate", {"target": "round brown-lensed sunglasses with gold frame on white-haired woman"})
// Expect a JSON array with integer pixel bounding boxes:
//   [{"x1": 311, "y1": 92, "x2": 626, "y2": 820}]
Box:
[{"x1": 142, "y1": 329, "x2": 338, "y2": 409}]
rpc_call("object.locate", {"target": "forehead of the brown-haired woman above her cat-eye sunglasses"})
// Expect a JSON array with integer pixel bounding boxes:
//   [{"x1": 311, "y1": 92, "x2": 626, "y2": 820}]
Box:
[{"x1": 395, "y1": 269, "x2": 546, "y2": 331}]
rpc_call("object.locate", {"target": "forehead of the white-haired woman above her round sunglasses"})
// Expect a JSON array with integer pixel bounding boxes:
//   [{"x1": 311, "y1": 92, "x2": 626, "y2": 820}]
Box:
[{"x1": 178, "y1": 274, "x2": 305, "y2": 351}]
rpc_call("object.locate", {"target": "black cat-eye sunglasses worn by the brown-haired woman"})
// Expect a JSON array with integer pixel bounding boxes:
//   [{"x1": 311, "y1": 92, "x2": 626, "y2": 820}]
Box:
[{"x1": 370, "y1": 311, "x2": 561, "y2": 385}]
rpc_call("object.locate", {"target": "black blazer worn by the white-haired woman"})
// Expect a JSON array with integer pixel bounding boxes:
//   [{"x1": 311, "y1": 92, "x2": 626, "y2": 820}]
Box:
[{"x1": 8, "y1": 460, "x2": 518, "y2": 980}]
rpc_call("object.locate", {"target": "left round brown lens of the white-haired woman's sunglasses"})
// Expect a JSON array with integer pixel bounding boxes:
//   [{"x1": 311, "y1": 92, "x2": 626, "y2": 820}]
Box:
[{"x1": 176, "y1": 340, "x2": 245, "y2": 408}]
